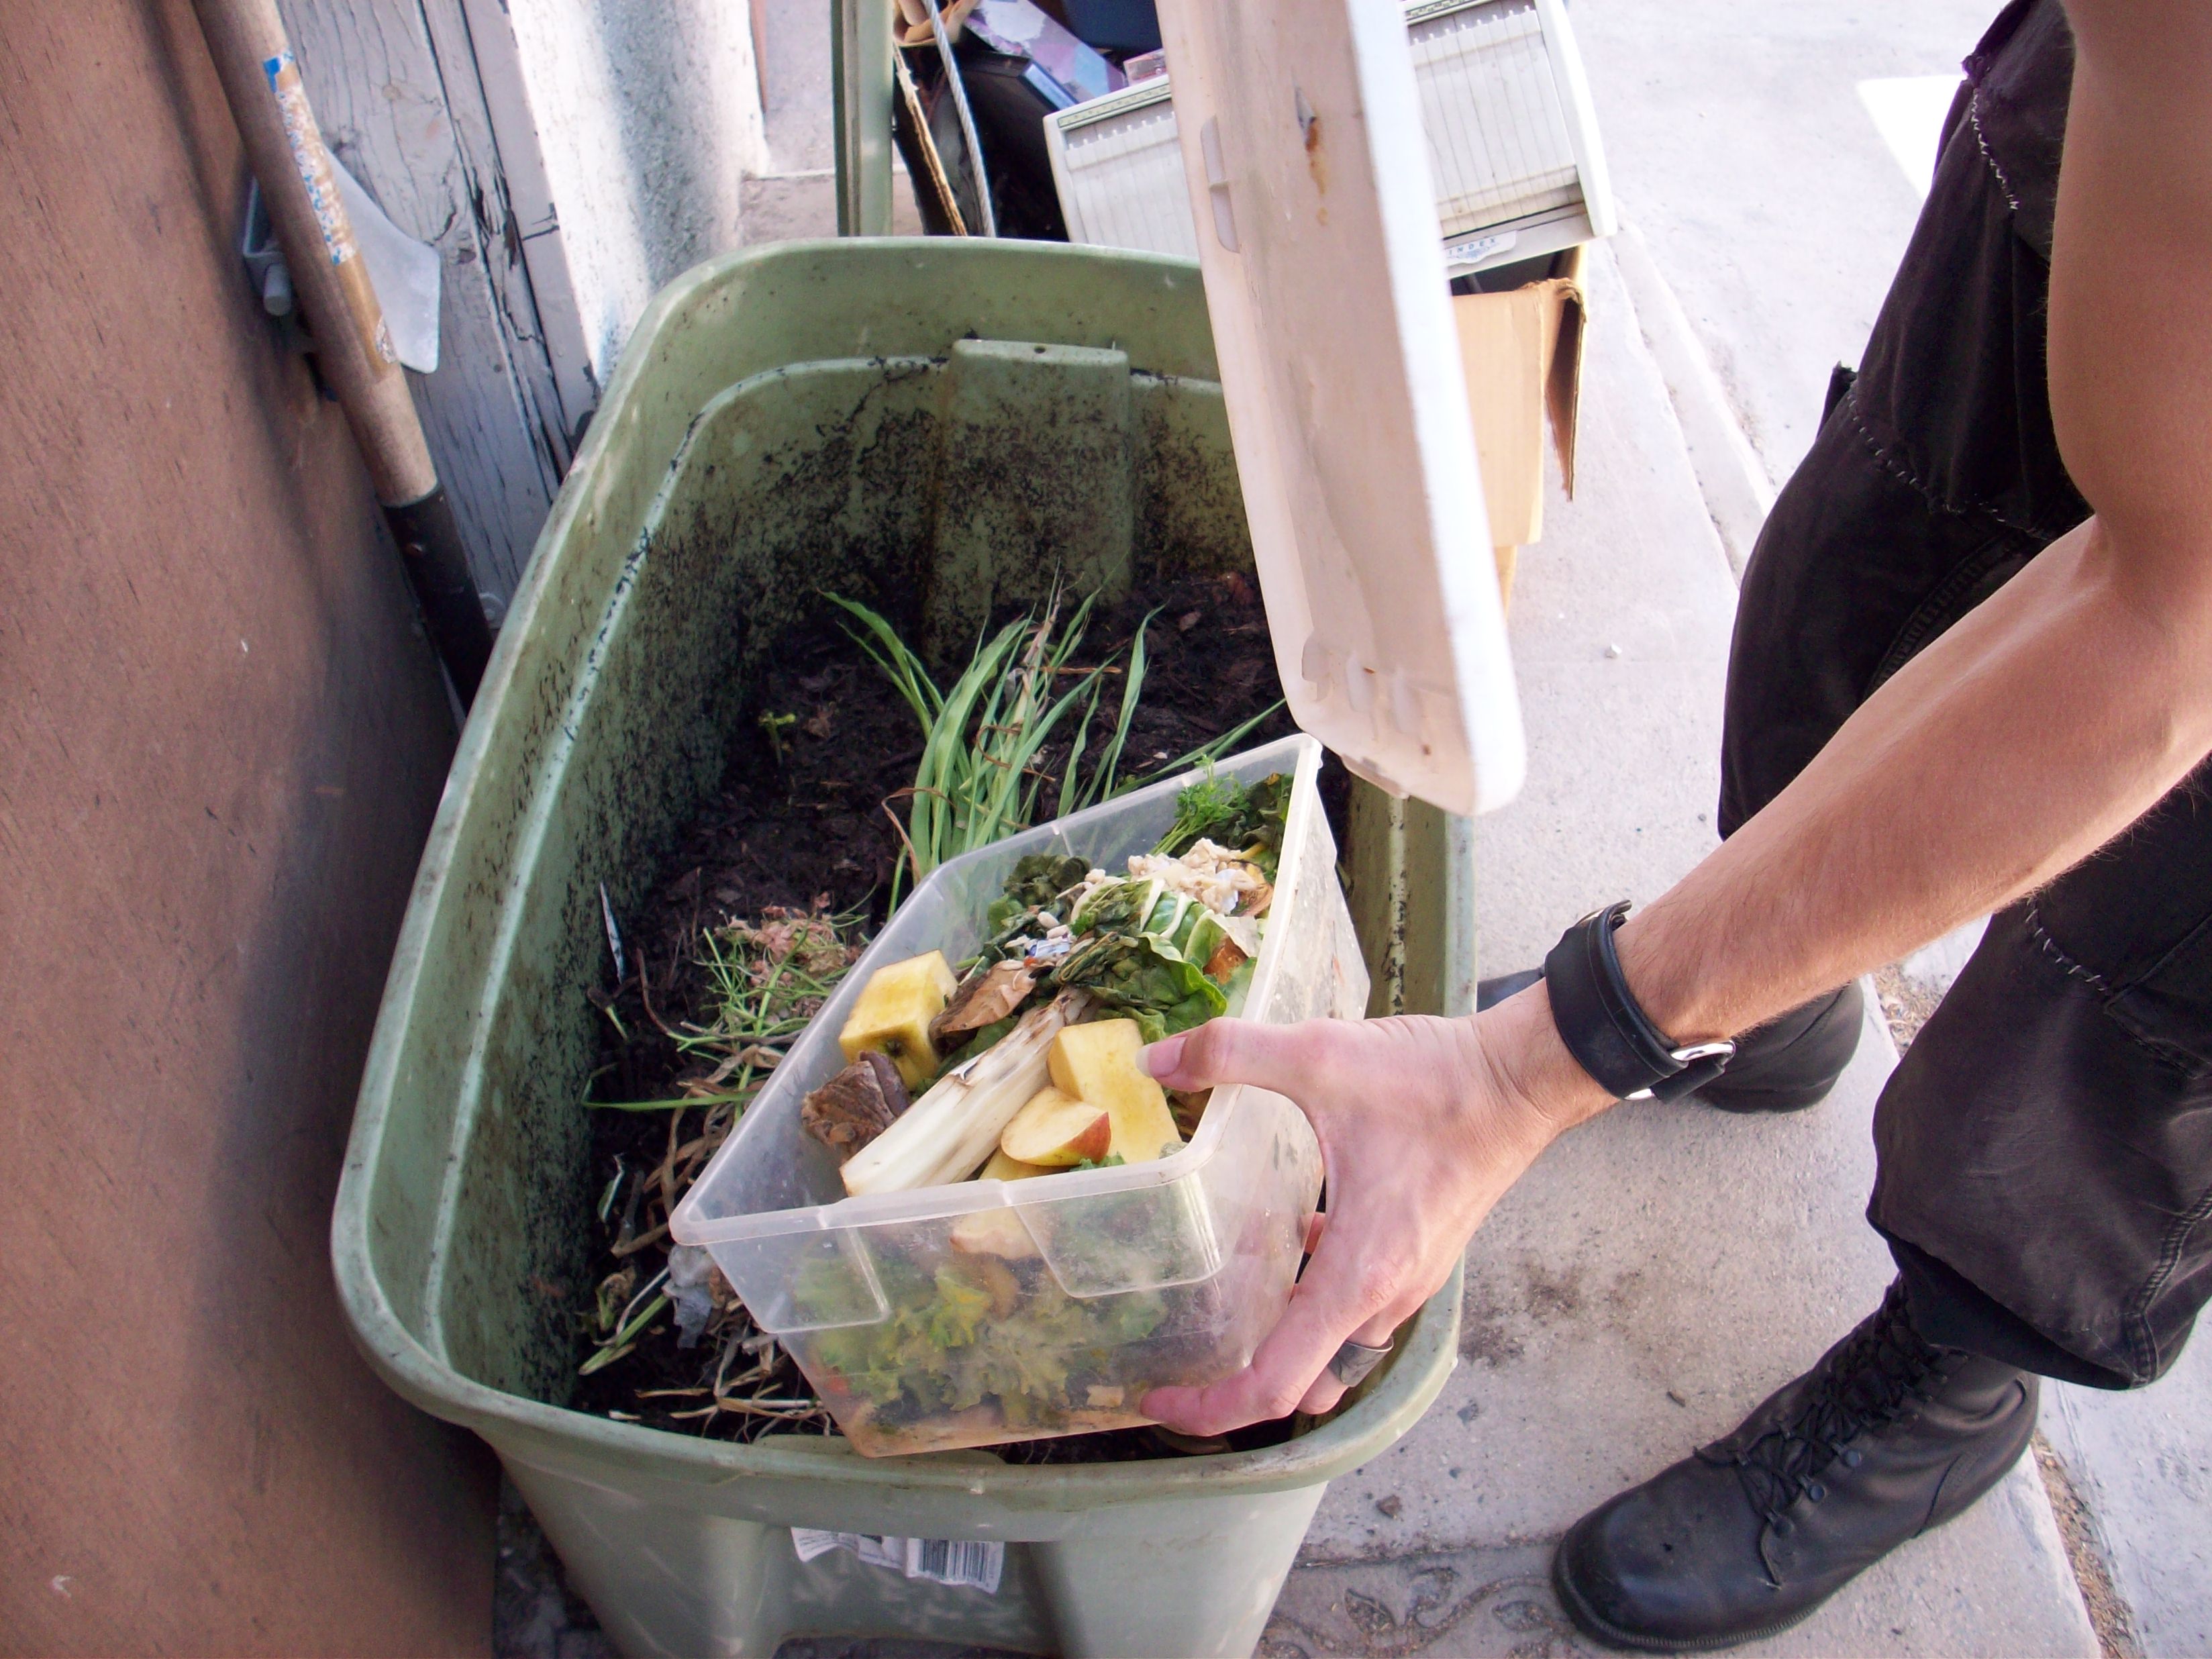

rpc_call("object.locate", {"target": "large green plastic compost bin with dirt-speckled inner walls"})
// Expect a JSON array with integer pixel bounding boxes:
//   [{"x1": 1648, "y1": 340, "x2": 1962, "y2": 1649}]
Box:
[{"x1": 332, "y1": 239, "x2": 1473, "y2": 1654}]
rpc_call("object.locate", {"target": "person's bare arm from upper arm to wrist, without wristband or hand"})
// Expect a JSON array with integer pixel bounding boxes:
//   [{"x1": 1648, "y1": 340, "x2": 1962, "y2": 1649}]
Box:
[{"x1": 1493, "y1": 0, "x2": 2212, "y2": 1117}]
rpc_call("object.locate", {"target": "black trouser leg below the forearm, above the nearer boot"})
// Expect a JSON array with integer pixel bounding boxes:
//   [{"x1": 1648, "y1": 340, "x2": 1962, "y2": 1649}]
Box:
[{"x1": 1867, "y1": 787, "x2": 2212, "y2": 1387}]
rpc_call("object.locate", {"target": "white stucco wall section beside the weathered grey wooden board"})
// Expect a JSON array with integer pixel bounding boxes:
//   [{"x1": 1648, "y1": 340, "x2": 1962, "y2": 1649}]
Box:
[{"x1": 509, "y1": 0, "x2": 770, "y2": 385}]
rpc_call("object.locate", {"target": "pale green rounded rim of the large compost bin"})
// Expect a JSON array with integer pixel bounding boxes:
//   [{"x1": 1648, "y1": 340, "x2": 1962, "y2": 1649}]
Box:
[{"x1": 330, "y1": 237, "x2": 1464, "y2": 1509}]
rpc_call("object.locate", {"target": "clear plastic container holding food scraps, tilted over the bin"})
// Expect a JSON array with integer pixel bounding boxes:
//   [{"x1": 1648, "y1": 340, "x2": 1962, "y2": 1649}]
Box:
[{"x1": 670, "y1": 737, "x2": 1367, "y2": 1456}]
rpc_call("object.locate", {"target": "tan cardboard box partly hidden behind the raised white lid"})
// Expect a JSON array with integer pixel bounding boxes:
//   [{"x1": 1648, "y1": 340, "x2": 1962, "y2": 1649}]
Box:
[{"x1": 1451, "y1": 248, "x2": 1584, "y2": 599}]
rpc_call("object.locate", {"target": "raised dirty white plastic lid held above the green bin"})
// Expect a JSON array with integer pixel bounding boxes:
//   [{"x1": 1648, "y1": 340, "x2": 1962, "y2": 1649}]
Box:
[{"x1": 1159, "y1": 0, "x2": 1524, "y2": 814}]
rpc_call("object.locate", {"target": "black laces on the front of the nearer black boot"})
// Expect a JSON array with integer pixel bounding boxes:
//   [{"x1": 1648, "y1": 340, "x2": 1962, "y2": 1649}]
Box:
[{"x1": 1734, "y1": 1285, "x2": 1942, "y2": 1522}]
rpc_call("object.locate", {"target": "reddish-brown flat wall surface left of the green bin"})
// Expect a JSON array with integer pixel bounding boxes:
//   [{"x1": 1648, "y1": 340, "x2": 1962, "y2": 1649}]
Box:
[{"x1": 0, "y1": 0, "x2": 493, "y2": 1654}]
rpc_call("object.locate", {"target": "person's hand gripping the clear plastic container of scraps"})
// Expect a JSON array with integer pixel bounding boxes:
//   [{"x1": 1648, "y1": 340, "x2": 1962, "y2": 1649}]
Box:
[{"x1": 1144, "y1": 987, "x2": 1608, "y2": 1436}]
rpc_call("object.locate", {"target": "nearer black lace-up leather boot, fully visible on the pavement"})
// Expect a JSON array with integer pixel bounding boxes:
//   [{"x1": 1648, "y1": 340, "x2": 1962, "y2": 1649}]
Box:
[{"x1": 1550, "y1": 1283, "x2": 2038, "y2": 1652}]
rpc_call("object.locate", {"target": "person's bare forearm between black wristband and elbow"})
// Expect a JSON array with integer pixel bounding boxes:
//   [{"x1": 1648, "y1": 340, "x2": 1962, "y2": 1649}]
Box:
[{"x1": 1619, "y1": 520, "x2": 2212, "y2": 1066}]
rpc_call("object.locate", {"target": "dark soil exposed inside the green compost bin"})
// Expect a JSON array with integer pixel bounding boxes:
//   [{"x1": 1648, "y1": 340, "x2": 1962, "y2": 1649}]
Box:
[{"x1": 570, "y1": 575, "x2": 1350, "y2": 1462}]
